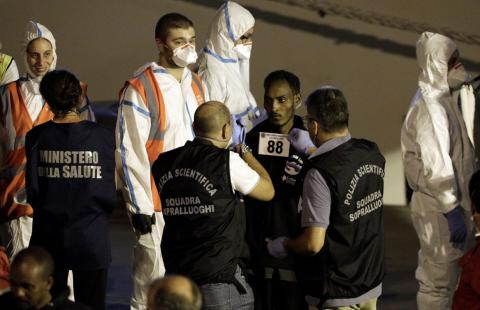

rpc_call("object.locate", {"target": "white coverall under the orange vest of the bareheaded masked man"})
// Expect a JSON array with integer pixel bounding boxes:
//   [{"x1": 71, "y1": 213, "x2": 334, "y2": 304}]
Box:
[{"x1": 115, "y1": 62, "x2": 208, "y2": 309}]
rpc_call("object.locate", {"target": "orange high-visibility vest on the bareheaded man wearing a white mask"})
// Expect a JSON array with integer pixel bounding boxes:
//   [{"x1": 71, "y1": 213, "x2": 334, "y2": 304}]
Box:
[{"x1": 120, "y1": 67, "x2": 205, "y2": 212}]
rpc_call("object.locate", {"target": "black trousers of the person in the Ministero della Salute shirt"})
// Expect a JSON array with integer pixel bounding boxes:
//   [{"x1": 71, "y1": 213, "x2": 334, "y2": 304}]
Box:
[{"x1": 52, "y1": 267, "x2": 108, "y2": 310}]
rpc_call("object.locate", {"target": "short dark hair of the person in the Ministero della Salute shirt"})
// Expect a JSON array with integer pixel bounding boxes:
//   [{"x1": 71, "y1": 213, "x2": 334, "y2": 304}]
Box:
[{"x1": 40, "y1": 70, "x2": 82, "y2": 116}]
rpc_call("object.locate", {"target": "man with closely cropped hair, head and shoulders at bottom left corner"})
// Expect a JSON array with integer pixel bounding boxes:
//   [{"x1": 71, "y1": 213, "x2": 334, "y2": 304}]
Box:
[{"x1": 0, "y1": 246, "x2": 90, "y2": 310}]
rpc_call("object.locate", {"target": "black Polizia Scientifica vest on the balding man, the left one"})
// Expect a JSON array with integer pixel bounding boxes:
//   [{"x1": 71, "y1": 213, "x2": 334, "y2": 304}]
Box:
[{"x1": 152, "y1": 140, "x2": 248, "y2": 285}]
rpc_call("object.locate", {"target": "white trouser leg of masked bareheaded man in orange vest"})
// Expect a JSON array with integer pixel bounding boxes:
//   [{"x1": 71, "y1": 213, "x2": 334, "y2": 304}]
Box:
[{"x1": 130, "y1": 212, "x2": 165, "y2": 310}]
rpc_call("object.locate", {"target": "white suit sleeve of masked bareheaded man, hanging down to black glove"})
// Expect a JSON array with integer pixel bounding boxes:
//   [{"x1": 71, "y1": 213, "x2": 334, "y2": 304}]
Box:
[{"x1": 115, "y1": 87, "x2": 154, "y2": 215}]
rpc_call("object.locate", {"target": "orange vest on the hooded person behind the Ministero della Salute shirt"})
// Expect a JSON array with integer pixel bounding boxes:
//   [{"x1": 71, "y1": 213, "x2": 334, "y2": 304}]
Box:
[{"x1": 0, "y1": 81, "x2": 87, "y2": 222}]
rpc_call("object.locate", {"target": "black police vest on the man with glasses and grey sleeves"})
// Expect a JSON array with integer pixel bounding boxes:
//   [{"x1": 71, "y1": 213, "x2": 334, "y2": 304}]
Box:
[{"x1": 300, "y1": 139, "x2": 385, "y2": 300}]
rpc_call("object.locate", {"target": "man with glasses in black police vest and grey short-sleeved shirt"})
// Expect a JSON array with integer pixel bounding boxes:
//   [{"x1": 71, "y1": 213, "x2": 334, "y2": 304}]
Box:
[{"x1": 267, "y1": 86, "x2": 385, "y2": 310}]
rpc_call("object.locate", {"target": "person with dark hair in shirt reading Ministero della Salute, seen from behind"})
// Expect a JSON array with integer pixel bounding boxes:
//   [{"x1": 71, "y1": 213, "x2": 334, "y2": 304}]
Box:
[{"x1": 25, "y1": 70, "x2": 117, "y2": 309}]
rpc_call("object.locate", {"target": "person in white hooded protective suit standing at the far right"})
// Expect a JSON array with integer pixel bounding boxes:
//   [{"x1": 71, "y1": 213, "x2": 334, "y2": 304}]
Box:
[{"x1": 401, "y1": 32, "x2": 476, "y2": 310}]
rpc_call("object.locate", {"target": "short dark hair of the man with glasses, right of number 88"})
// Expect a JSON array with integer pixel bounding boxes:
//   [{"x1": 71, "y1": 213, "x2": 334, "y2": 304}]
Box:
[{"x1": 306, "y1": 87, "x2": 348, "y2": 133}]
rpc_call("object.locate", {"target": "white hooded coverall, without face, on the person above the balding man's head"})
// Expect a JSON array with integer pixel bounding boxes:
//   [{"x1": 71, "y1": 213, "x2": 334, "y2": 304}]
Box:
[{"x1": 199, "y1": 1, "x2": 257, "y2": 121}]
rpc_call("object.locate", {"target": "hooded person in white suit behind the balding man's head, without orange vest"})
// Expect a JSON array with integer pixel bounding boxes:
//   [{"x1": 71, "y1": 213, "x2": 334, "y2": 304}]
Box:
[{"x1": 198, "y1": 1, "x2": 266, "y2": 144}]
